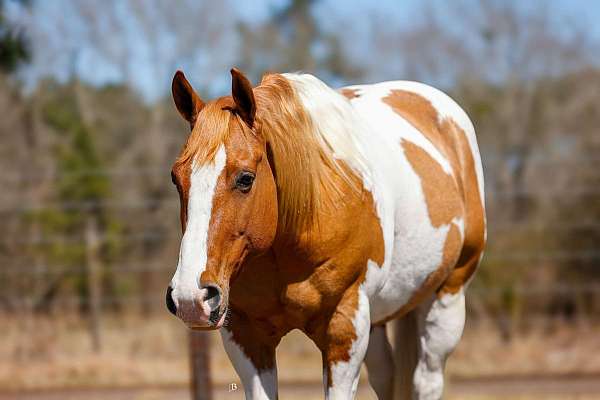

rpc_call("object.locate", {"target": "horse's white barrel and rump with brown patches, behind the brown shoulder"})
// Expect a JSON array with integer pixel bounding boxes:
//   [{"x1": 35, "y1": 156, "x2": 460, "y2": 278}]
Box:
[{"x1": 342, "y1": 81, "x2": 485, "y2": 320}]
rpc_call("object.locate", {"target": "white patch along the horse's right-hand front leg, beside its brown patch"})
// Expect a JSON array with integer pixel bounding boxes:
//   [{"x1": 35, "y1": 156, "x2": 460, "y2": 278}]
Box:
[{"x1": 323, "y1": 285, "x2": 371, "y2": 400}]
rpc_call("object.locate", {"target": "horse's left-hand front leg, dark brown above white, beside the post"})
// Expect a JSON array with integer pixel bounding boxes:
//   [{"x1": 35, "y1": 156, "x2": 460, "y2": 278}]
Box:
[{"x1": 221, "y1": 317, "x2": 277, "y2": 400}]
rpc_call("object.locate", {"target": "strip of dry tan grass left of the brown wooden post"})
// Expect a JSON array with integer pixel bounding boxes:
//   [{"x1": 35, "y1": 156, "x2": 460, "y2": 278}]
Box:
[{"x1": 0, "y1": 317, "x2": 188, "y2": 388}]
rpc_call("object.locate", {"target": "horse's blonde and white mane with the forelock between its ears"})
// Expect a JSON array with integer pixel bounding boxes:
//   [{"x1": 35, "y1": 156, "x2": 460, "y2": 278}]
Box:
[{"x1": 176, "y1": 74, "x2": 367, "y2": 236}]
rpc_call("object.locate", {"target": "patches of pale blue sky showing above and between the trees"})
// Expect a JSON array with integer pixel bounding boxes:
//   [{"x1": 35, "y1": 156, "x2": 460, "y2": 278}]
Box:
[{"x1": 7, "y1": 0, "x2": 600, "y2": 98}]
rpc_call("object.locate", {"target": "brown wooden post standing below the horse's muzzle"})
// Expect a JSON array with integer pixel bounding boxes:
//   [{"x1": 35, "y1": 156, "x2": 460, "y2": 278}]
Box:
[{"x1": 190, "y1": 331, "x2": 213, "y2": 400}]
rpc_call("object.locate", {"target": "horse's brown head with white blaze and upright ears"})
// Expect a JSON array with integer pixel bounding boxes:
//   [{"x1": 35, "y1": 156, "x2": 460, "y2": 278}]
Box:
[{"x1": 166, "y1": 69, "x2": 277, "y2": 329}]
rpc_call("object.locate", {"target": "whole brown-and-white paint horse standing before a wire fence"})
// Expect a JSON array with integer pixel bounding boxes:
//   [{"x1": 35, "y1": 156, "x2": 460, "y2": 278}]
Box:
[{"x1": 166, "y1": 69, "x2": 486, "y2": 399}]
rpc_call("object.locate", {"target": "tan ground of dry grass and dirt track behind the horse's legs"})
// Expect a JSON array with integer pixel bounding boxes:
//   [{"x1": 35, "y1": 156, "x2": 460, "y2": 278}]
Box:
[{"x1": 0, "y1": 314, "x2": 600, "y2": 400}]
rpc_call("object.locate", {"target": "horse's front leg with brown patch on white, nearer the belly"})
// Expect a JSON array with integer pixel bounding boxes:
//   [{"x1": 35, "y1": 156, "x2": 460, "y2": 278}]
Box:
[{"x1": 321, "y1": 286, "x2": 371, "y2": 400}]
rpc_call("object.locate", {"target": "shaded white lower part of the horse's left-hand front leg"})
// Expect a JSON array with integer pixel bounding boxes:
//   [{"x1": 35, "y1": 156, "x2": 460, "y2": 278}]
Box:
[{"x1": 220, "y1": 329, "x2": 277, "y2": 400}]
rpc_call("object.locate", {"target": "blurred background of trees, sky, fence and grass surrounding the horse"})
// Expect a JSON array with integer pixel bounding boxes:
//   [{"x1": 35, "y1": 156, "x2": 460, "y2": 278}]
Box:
[{"x1": 0, "y1": 0, "x2": 600, "y2": 400}]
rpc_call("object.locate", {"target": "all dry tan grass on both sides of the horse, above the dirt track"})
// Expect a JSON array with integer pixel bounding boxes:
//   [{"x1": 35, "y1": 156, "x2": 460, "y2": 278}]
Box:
[{"x1": 0, "y1": 313, "x2": 600, "y2": 390}]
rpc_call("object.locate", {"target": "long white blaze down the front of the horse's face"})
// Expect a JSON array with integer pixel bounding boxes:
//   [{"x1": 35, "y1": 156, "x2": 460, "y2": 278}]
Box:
[{"x1": 171, "y1": 145, "x2": 226, "y2": 319}]
